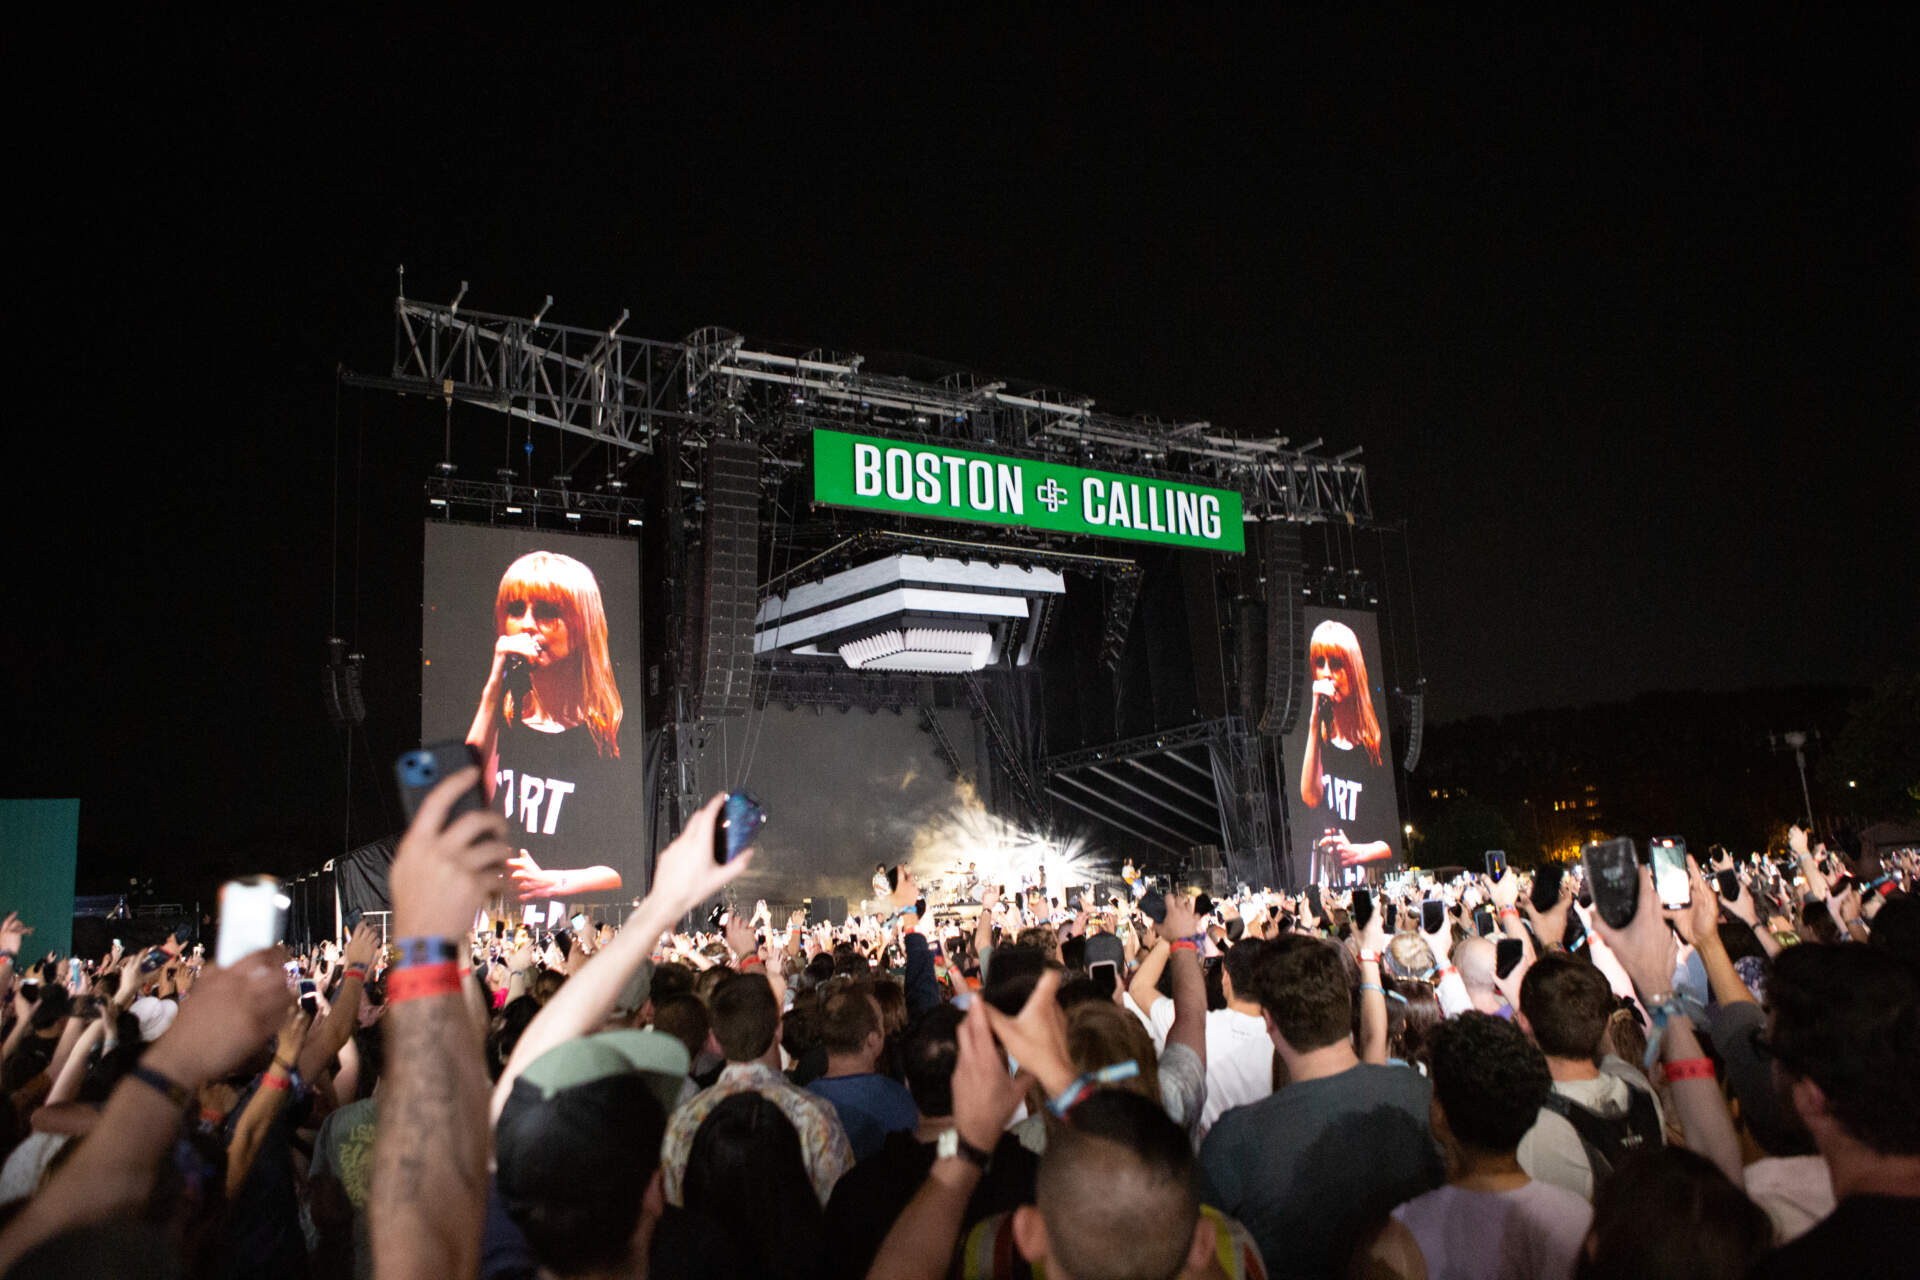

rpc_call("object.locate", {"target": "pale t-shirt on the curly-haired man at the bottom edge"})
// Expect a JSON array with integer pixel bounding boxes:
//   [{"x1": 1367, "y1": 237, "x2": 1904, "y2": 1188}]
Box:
[{"x1": 1394, "y1": 1182, "x2": 1594, "y2": 1280}]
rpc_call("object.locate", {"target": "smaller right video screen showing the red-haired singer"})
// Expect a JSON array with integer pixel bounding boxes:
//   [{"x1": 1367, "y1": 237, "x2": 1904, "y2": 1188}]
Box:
[{"x1": 1283, "y1": 604, "x2": 1402, "y2": 885}]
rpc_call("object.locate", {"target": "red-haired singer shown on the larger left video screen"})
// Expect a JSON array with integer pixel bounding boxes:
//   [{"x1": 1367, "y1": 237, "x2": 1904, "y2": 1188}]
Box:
[{"x1": 467, "y1": 551, "x2": 620, "y2": 900}]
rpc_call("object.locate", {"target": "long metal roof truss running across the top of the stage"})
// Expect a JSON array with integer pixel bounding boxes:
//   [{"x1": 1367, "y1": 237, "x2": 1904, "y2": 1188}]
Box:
[{"x1": 348, "y1": 282, "x2": 1373, "y2": 524}]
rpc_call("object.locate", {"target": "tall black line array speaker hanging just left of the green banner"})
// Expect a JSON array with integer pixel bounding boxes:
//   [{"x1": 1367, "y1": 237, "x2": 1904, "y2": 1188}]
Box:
[{"x1": 695, "y1": 438, "x2": 760, "y2": 720}]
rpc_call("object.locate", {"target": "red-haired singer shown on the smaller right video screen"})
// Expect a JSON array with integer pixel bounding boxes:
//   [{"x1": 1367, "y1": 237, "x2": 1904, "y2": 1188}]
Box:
[{"x1": 1300, "y1": 618, "x2": 1394, "y2": 877}]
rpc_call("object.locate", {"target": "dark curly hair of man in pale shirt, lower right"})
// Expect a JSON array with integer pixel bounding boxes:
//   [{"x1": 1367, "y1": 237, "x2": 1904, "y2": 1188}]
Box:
[{"x1": 1427, "y1": 1011, "x2": 1553, "y2": 1151}]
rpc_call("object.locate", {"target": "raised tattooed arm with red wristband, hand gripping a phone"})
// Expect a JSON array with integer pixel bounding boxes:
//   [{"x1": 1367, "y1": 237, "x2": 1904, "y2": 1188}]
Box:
[{"x1": 369, "y1": 770, "x2": 513, "y2": 1280}]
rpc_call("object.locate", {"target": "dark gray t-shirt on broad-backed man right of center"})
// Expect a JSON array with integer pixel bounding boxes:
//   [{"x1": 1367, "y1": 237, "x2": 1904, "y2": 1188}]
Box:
[{"x1": 1200, "y1": 1063, "x2": 1446, "y2": 1276}]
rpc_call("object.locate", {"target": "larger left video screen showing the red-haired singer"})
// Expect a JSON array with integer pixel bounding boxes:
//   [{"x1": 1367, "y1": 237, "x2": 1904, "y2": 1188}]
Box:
[{"x1": 420, "y1": 522, "x2": 651, "y2": 902}]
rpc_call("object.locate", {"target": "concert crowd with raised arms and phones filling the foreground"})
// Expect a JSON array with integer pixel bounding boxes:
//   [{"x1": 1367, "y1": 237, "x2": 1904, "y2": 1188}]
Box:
[{"x1": 0, "y1": 771, "x2": 1920, "y2": 1280}]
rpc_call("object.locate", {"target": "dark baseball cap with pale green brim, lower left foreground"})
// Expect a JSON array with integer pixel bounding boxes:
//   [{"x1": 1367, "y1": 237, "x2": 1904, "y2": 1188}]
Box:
[{"x1": 493, "y1": 1031, "x2": 691, "y2": 1203}]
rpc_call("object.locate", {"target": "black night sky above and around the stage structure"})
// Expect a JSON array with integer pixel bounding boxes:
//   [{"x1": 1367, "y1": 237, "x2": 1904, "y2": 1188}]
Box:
[{"x1": 8, "y1": 10, "x2": 1920, "y2": 889}]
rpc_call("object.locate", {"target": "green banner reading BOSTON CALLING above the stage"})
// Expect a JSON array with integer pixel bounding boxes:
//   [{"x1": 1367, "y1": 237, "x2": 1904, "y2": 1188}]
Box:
[{"x1": 814, "y1": 430, "x2": 1246, "y2": 551}]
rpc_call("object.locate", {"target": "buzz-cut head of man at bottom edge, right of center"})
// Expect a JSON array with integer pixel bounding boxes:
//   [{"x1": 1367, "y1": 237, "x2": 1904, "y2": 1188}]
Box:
[{"x1": 1035, "y1": 1088, "x2": 1200, "y2": 1280}]
